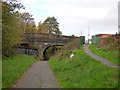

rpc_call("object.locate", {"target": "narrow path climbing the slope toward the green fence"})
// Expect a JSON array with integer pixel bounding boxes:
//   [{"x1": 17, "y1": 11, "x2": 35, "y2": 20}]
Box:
[{"x1": 83, "y1": 45, "x2": 120, "y2": 70}]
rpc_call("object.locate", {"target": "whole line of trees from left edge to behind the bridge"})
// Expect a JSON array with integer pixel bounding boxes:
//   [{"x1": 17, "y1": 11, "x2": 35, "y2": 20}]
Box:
[{"x1": 2, "y1": 0, "x2": 62, "y2": 57}]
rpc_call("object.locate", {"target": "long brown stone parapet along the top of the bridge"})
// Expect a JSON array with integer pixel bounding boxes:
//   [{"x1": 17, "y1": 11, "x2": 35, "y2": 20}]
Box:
[{"x1": 24, "y1": 33, "x2": 78, "y2": 43}]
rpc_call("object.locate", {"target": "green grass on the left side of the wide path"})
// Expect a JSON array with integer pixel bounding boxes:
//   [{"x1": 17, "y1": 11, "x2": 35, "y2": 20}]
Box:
[{"x1": 2, "y1": 55, "x2": 36, "y2": 88}]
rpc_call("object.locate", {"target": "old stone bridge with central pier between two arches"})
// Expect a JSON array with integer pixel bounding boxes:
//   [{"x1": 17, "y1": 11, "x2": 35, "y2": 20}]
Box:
[{"x1": 21, "y1": 33, "x2": 78, "y2": 59}]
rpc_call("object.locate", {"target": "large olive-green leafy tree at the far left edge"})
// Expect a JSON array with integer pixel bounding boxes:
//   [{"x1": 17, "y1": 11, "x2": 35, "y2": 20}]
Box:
[{"x1": 2, "y1": 2, "x2": 23, "y2": 56}]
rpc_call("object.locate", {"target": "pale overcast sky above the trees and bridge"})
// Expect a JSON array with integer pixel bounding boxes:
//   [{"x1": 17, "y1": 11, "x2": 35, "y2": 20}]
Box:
[{"x1": 21, "y1": 0, "x2": 119, "y2": 39}]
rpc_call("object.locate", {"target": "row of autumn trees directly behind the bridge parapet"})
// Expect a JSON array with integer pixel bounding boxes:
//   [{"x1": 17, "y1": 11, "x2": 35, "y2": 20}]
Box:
[{"x1": 19, "y1": 12, "x2": 62, "y2": 35}]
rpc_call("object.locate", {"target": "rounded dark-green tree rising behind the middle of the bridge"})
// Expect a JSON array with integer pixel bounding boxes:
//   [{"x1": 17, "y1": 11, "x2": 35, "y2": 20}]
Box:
[{"x1": 43, "y1": 17, "x2": 62, "y2": 34}]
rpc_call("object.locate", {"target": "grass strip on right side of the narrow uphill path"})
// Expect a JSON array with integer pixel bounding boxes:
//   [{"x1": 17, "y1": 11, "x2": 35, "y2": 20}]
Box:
[{"x1": 89, "y1": 45, "x2": 118, "y2": 65}]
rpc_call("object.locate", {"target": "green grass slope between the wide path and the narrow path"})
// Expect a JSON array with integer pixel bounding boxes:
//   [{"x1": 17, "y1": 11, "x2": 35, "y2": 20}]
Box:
[{"x1": 49, "y1": 49, "x2": 118, "y2": 88}]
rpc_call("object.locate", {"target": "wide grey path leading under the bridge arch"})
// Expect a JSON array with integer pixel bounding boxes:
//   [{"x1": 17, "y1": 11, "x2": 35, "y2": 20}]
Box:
[{"x1": 15, "y1": 61, "x2": 58, "y2": 88}]
